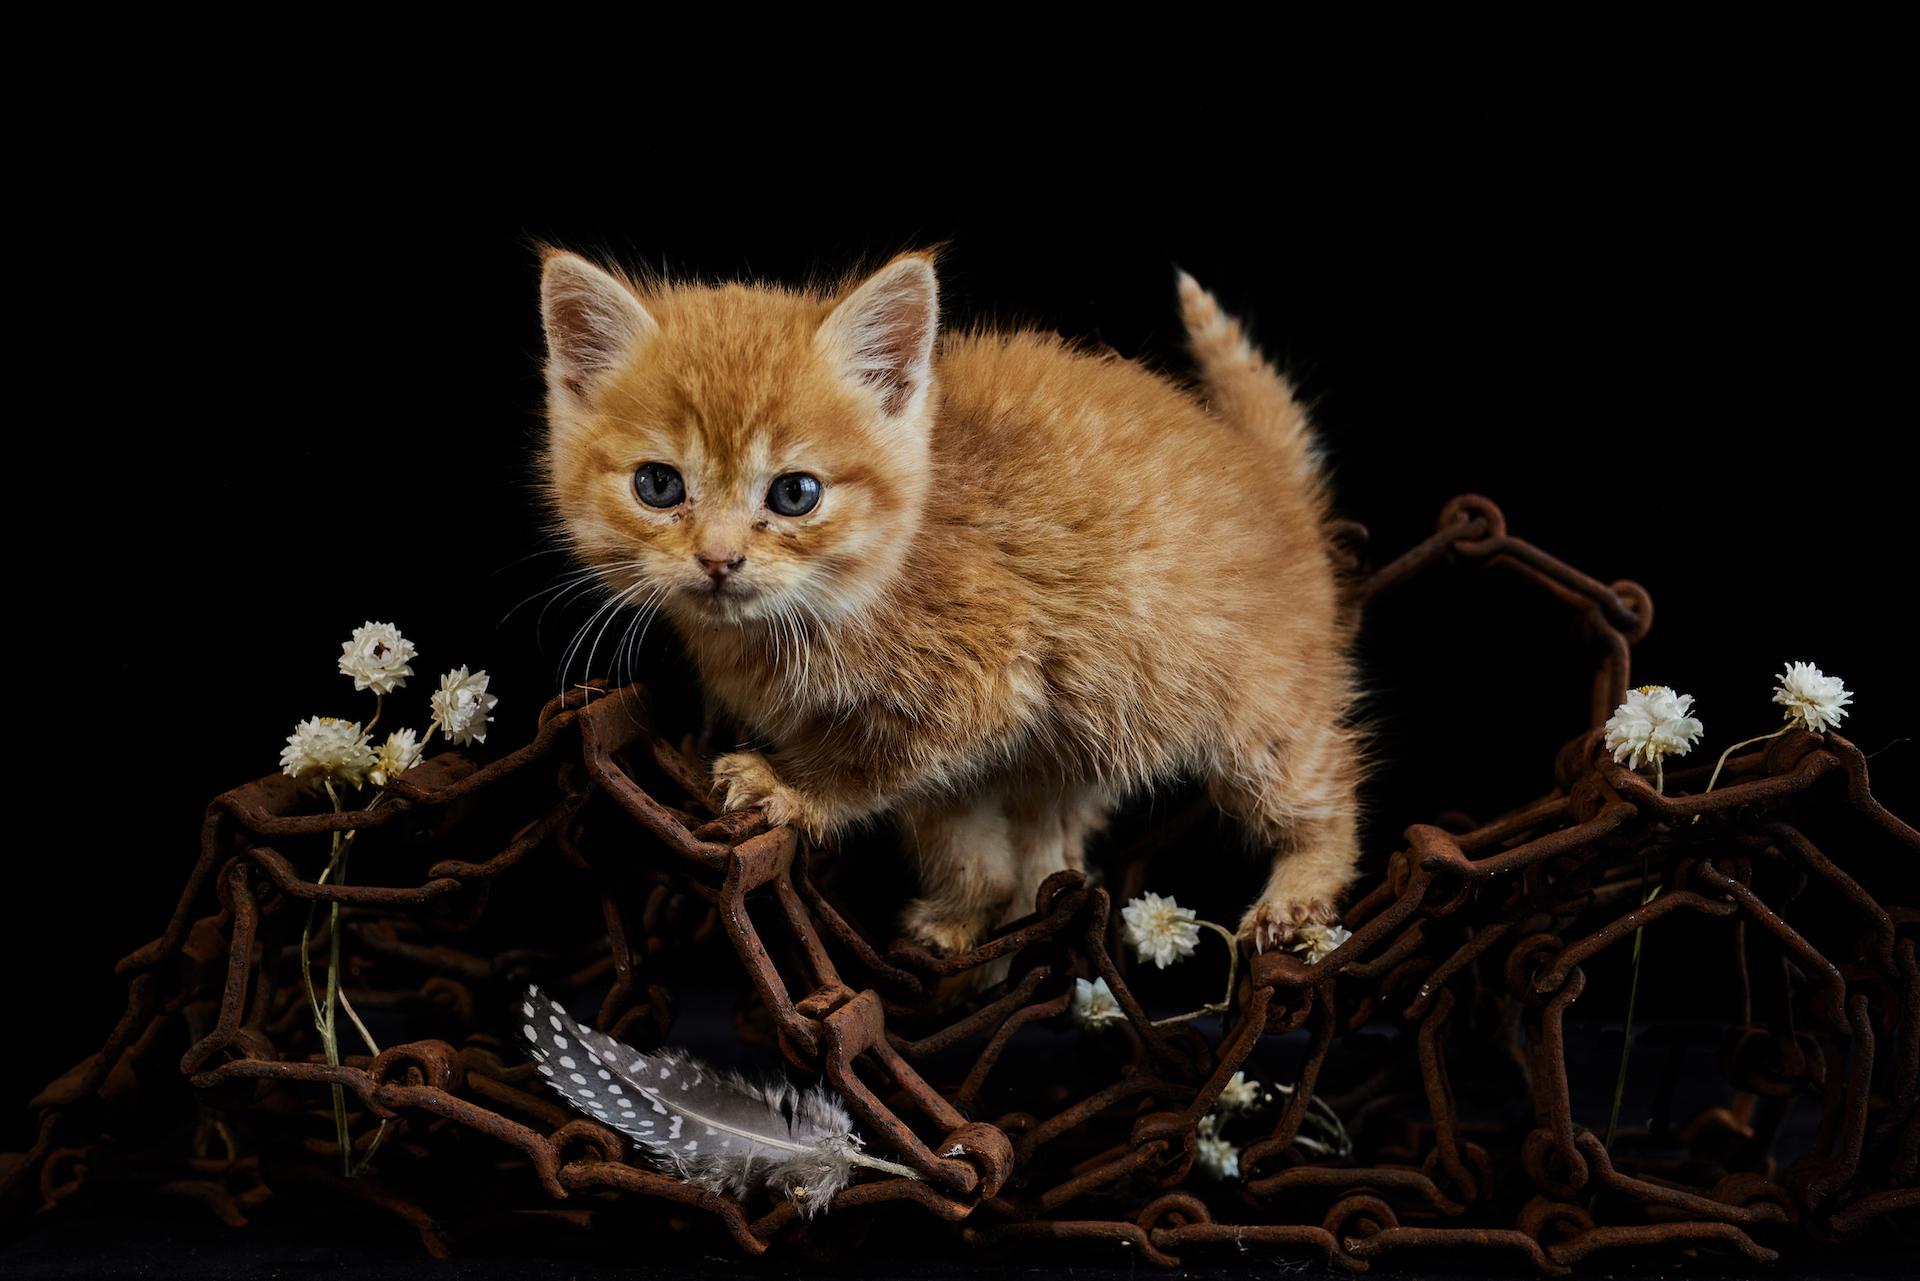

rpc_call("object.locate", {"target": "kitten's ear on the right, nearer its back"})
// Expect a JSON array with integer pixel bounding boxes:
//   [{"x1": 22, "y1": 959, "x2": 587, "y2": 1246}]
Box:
[{"x1": 814, "y1": 254, "x2": 941, "y2": 417}]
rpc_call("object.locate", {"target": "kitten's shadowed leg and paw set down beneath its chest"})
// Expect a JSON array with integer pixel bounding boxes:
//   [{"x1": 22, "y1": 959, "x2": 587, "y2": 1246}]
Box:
[{"x1": 899, "y1": 789, "x2": 1031, "y2": 956}]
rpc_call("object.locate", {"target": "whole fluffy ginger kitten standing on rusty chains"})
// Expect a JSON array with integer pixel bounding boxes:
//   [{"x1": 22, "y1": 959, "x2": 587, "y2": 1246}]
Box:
[{"x1": 540, "y1": 246, "x2": 1361, "y2": 953}]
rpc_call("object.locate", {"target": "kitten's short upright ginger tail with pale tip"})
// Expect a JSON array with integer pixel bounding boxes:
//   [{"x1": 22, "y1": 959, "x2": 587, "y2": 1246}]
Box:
[{"x1": 1175, "y1": 269, "x2": 1325, "y2": 492}]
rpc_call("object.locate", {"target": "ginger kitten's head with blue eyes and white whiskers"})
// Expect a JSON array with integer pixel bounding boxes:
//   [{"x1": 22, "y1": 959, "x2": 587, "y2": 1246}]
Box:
[{"x1": 540, "y1": 248, "x2": 939, "y2": 624}]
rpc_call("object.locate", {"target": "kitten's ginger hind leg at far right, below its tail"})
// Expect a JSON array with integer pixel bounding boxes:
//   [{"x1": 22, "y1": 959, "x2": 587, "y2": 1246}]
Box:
[{"x1": 1208, "y1": 726, "x2": 1359, "y2": 951}]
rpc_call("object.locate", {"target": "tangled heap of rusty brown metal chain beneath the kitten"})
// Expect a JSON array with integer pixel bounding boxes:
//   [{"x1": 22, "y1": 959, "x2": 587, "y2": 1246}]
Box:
[{"x1": 6, "y1": 495, "x2": 1920, "y2": 1275}]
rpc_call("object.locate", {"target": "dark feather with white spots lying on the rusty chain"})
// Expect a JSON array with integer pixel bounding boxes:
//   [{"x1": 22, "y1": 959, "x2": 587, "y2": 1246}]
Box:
[{"x1": 520, "y1": 987, "x2": 920, "y2": 1218}]
